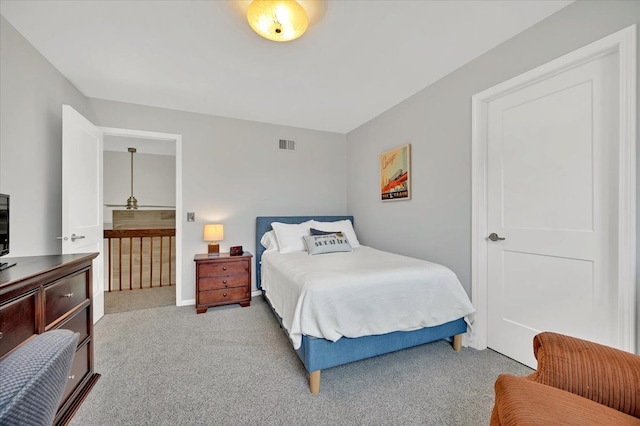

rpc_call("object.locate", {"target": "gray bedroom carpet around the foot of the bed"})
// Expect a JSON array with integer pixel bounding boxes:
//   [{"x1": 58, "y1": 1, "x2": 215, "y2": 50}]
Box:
[{"x1": 71, "y1": 297, "x2": 532, "y2": 425}]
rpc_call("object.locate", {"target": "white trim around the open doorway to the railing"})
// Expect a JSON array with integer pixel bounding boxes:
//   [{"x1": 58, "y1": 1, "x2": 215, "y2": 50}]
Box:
[{"x1": 99, "y1": 127, "x2": 185, "y2": 306}]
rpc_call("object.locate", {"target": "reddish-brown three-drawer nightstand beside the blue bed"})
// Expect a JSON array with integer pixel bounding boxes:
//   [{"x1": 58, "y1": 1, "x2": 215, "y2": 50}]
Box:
[{"x1": 193, "y1": 251, "x2": 253, "y2": 314}]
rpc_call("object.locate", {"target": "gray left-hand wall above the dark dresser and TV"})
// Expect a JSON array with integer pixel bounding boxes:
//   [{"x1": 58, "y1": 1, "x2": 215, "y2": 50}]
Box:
[{"x1": 0, "y1": 16, "x2": 92, "y2": 256}]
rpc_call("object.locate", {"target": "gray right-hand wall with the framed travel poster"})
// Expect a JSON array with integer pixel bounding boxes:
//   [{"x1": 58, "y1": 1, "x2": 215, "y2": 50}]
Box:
[{"x1": 347, "y1": 1, "x2": 640, "y2": 348}]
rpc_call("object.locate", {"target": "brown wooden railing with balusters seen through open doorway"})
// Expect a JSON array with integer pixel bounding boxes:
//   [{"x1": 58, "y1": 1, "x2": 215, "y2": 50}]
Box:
[{"x1": 104, "y1": 228, "x2": 176, "y2": 291}]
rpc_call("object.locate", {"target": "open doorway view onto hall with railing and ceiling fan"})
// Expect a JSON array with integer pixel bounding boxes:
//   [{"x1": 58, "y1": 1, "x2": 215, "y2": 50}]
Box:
[{"x1": 103, "y1": 134, "x2": 177, "y2": 314}]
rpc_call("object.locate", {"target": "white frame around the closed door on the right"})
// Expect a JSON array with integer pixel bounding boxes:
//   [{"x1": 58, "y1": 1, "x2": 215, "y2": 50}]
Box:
[{"x1": 466, "y1": 25, "x2": 637, "y2": 352}]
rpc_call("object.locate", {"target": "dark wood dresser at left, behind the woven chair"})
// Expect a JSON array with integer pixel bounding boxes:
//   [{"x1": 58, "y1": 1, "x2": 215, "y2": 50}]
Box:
[{"x1": 0, "y1": 253, "x2": 100, "y2": 425}]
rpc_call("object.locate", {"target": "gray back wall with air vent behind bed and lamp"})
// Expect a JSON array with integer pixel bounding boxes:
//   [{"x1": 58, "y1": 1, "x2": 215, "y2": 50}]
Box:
[{"x1": 89, "y1": 99, "x2": 347, "y2": 300}]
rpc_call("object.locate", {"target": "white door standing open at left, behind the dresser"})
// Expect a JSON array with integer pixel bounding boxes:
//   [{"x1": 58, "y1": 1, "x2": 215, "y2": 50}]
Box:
[{"x1": 62, "y1": 105, "x2": 104, "y2": 323}]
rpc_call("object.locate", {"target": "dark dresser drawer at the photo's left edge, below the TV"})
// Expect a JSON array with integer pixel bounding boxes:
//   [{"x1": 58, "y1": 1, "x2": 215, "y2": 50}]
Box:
[{"x1": 0, "y1": 292, "x2": 38, "y2": 357}]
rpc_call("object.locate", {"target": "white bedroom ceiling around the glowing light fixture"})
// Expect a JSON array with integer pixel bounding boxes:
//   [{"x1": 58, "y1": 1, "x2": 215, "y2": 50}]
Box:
[{"x1": 0, "y1": 0, "x2": 572, "y2": 133}]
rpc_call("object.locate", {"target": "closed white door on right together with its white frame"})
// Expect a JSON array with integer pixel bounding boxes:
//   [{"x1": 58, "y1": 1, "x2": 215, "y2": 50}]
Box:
[{"x1": 469, "y1": 26, "x2": 636, "y2": 362}]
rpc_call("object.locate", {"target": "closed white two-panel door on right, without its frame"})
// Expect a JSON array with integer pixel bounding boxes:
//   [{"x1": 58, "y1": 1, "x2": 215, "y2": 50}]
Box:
[{"x1": 487, "y1": 52, "x2": 618, "y2": 368}]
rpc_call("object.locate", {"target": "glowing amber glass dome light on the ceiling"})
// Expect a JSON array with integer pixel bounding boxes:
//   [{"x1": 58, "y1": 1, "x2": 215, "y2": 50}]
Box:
[{"x1": 247, "y1": 0, "x2": 309, "y2": 41}]
